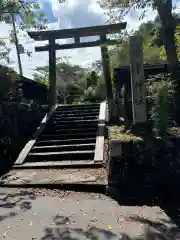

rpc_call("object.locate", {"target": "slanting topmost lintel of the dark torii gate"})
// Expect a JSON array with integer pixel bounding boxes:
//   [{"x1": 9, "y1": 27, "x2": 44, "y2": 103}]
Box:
[{"x1": 28, "y1": 22, "x2": 127, "y2": 41}]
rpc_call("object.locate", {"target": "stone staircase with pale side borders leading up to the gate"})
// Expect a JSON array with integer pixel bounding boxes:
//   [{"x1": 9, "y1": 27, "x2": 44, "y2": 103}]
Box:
[{"x1": 14, "y1": 103, "x2": 106, "y2": 168}]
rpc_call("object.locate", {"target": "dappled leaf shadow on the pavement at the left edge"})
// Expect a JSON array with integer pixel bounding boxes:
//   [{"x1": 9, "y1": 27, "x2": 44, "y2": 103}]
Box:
[{"x1": 0, "y1": 189, "x2": 36, "y2": 222}]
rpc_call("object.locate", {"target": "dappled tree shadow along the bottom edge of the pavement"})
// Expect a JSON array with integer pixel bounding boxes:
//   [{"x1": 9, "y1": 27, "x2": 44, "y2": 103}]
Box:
[{"x1": 41, "y1": 215, "x2": 180, "y2": 240}]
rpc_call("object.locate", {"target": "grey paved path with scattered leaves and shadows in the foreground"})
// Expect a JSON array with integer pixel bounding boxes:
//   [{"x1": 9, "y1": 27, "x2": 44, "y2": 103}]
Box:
[{"x1": 0, "y1": 189, "x2": 180, "y2": 240}]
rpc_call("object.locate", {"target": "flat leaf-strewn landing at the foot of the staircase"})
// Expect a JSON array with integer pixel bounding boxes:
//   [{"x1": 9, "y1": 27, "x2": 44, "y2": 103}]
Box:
[{"x1": 2, "y1": 167, "x2": 107, "y2": 185}]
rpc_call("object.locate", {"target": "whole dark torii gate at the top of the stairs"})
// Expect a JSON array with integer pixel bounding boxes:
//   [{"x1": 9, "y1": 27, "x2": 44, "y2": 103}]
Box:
[{"x1": 28, "y1": 22, "x2": 127, "y2": 110}]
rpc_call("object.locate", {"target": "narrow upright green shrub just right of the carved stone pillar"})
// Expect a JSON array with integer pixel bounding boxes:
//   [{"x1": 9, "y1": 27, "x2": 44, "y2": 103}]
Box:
[{"x1": 147, "y1": 74, "x2": 175, "y2": 137}]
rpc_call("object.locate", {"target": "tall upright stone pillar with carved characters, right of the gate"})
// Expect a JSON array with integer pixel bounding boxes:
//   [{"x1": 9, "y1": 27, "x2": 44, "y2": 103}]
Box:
[{"x1": 130, "y1": 36, "x2": 147, "y2": 124}]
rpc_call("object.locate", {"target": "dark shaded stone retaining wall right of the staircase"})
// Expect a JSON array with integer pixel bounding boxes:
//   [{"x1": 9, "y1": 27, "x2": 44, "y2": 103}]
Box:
[{"x1": 108, "y1": 137, "x2": 180, "y2": 199}]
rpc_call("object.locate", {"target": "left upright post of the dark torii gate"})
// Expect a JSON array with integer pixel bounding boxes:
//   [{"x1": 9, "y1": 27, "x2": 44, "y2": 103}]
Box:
[{"x1": 48, "y1": 39, "x2": 57, "y2": 111}]
